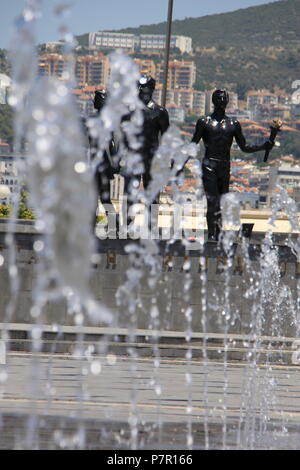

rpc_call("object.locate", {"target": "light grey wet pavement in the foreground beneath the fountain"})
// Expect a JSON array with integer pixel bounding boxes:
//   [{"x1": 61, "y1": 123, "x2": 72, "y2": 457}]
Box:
[{"x1": 0, "y1": 346, "x2": 300, "y2": 449}]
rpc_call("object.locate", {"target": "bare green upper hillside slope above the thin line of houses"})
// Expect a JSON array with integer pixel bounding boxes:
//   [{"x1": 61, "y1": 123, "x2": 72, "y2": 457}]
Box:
[{"x1": 119, "y1": 0, "x2": 300, "y2": 47}]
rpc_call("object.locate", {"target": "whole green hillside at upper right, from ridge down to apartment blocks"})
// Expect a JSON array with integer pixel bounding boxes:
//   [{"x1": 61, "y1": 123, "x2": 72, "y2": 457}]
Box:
[{"x1": 75, "y1": 0, "x2": 300, "y2": 98}]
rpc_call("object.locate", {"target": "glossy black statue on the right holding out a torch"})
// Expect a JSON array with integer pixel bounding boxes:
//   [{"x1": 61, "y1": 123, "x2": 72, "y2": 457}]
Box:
[{"x1": 178, "y1": 90, "x2": 274, "y2": 241}]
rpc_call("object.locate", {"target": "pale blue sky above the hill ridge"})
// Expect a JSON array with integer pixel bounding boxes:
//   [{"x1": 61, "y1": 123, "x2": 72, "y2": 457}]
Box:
[{"x1": 0, "y1": 0, "x2": 276, "y2": 48}]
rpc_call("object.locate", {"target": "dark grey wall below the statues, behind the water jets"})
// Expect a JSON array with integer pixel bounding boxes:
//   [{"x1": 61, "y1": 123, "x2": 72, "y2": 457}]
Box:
[{"x1": 0, "y1": 221, "x2": 299, "y2": 337}]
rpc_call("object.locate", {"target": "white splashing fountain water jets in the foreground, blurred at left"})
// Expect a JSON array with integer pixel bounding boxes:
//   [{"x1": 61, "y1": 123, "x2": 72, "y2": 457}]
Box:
[{"x1": 0, "y1": 1, "x2": 300, "y2": 449}]
